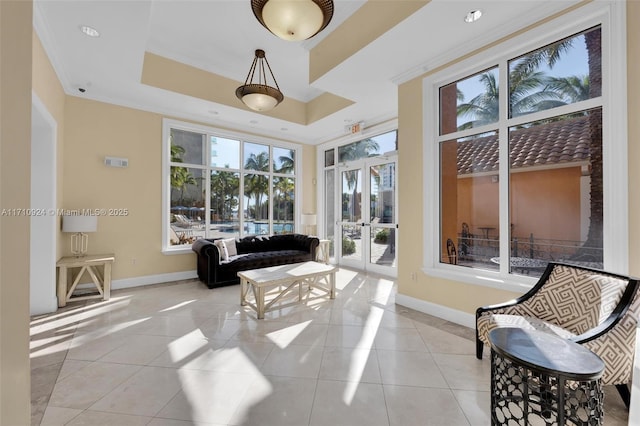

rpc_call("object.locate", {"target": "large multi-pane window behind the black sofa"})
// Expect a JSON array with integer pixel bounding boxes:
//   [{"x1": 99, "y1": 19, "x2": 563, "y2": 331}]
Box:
[{"x1": 163, "y1": 120, "x2": 298, "y2": 251}]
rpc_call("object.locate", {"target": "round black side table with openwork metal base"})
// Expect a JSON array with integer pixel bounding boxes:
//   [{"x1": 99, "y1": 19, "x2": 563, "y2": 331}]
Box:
[{"x1": 489, "y1": 328, "x2": 604, "y2": 426}]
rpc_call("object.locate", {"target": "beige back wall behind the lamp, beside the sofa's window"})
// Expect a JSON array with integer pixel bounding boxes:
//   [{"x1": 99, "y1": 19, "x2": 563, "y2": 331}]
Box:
[{"x1": 62, "y1": 96, "x2": 315, "y2": 280}]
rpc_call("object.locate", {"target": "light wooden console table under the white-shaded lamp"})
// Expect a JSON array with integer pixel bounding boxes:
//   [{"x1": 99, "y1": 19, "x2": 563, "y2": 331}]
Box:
[{"x1": 56, "y1": 254, "x2": 116, "y2": 308}]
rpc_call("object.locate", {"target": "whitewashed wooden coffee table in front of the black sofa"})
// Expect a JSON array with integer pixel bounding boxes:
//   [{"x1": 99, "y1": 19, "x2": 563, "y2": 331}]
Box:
[{"x1": 238, "y1": 262, "x2": 338, "y2": 319}]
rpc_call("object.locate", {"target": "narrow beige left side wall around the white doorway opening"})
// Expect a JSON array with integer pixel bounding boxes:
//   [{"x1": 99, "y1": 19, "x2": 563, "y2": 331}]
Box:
[{"x1": 32, "y1": 32, "x2": 66, "y2": 259}]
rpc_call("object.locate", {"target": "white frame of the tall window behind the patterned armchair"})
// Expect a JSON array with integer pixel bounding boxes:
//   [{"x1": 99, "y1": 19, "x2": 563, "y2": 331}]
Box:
[{"x1": 423, "y1": 2, "x2": 628, "y2": 292}]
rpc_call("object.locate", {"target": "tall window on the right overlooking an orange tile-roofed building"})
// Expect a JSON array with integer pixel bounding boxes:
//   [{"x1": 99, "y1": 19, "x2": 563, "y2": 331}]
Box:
[{"x1": 425, "y1": 2, "x2": 626, "y2": 281}]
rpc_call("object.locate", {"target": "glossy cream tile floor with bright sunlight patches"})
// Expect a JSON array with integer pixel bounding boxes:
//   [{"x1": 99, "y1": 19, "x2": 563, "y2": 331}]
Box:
[{"x1": 31, "y1": 269, "x2": 627, "y2": 426}]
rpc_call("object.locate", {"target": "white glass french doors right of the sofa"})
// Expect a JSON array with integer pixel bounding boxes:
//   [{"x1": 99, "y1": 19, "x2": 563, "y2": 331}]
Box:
[{"x1": 336, "y1": 157, "x2": 398, "y2": 276}]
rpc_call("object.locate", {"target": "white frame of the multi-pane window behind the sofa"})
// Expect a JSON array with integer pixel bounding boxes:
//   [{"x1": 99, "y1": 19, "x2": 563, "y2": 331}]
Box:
[{"x1": 161, "y1": 118, "x2": 303, "y2": 255}]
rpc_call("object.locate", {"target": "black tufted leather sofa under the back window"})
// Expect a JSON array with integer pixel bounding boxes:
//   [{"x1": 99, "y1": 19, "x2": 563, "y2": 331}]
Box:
[{"x1": 191, "y1": 234, "x2": 320, "y2": 288}]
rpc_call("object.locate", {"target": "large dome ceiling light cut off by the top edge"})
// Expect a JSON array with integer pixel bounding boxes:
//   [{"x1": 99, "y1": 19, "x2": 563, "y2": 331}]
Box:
[{"x1": 251, "y1": 0, "x2": 333, "y2": 41}]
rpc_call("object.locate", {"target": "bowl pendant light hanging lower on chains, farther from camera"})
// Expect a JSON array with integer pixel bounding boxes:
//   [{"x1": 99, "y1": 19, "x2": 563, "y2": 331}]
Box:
[{"x1": 236, "y1": 49, "x2": 284, "y2": 111}]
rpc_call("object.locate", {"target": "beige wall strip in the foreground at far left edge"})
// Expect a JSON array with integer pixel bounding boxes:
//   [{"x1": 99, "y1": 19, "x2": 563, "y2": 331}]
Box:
[{"x1": 0, "y1": 0, "x2": 33, "y2": 425}]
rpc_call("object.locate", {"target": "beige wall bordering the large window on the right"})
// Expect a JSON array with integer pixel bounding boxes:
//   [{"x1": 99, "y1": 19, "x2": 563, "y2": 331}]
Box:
[{"x1": 398, "y1": 1, "x2": 640, "y2": 314}]
